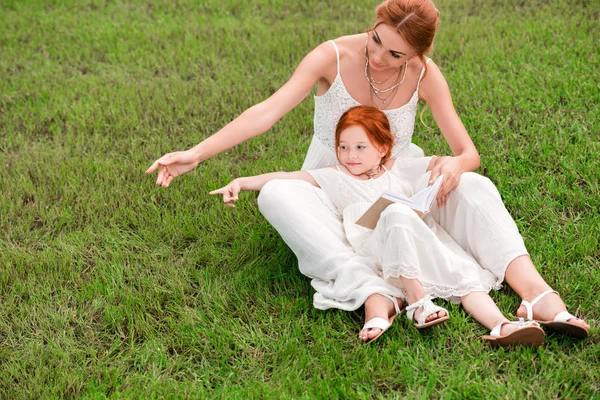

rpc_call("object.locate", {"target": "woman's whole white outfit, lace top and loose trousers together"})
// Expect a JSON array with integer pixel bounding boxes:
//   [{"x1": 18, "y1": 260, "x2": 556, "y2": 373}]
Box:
[{"x1": 258, "y1": 41, "x2": 527, "y2": 310}]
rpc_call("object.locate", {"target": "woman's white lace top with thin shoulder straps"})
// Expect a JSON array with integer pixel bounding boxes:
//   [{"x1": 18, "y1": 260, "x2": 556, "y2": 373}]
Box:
[{"x1": 302, "y1": 40, "x2": 430, "y2": 170}]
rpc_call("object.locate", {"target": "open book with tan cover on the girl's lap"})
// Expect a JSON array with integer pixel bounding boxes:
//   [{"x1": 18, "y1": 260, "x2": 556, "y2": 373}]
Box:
[{"x1": 356, "y1": 175, "x2": 444, "y2": 229}]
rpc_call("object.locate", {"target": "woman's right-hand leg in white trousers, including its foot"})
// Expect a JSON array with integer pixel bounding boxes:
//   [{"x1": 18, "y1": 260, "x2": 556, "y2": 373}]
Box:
[{"x1": 432, "y1": 172, "x2": 589, "y2": 329}]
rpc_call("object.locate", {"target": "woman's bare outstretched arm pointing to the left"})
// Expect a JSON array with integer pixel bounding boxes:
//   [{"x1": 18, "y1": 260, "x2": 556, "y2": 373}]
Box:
[{"x1": 146, "y1": 43, "x2": 336, "y2": 187}]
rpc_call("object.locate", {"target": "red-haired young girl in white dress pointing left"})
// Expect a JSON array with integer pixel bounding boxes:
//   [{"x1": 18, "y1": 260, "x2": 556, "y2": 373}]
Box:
[{"x1": 210, "y1": 106, "x2": 544, "y2": 346}]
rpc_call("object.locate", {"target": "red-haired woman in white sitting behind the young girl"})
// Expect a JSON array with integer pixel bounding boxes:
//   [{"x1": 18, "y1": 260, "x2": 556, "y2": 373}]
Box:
[{"x1": 147, "y1": 0, "x2": 589, "y2": 341}]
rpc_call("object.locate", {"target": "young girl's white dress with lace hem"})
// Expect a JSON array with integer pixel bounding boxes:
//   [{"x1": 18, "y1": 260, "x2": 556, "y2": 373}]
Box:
[{"x1": 308, "y1": 158, "x2": 502, "y2": 302}]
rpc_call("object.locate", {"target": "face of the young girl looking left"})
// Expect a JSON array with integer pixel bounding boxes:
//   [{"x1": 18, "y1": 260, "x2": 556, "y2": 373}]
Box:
[{"x1": 338, "y1": 125, "x2": 387, "y2": 175}]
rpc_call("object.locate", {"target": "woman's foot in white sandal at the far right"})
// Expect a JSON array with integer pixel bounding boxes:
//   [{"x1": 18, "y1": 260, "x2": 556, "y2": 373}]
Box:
[{"x1": 517, "y1": 290, "x2": 590, "y2": 337}]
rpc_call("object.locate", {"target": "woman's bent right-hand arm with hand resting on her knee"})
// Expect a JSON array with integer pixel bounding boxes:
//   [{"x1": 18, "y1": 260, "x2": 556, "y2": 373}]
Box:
[{"x1": 421, "y1": 61, "x2": 479, "y2": 207}]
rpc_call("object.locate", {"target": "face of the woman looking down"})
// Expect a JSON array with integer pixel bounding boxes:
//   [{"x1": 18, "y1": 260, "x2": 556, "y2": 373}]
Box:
[{"x1": 367, "y1": 24, "x2": 416, "y2": 72}]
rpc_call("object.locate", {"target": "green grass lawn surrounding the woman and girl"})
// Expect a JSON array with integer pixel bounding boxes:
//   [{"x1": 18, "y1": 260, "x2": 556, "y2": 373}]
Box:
[{"x1": 0, "y1": 0, "x2": 600, "y2": 399}]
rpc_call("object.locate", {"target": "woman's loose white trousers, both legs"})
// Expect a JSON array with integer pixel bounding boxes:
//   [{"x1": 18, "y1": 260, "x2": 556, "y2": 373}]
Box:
[{"x1": 258, "y1": 172, "x2": 527, "y2": 311}]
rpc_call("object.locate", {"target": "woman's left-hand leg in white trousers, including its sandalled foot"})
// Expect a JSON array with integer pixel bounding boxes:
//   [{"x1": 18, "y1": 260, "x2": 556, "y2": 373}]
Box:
[{"x1": 258, "y1": 180, "x2": 403, "y2": 337}]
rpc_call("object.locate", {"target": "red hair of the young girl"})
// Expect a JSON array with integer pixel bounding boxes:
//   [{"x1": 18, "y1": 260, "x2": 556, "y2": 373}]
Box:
[{"x1": 335, "y1": 106, "x2": 395, "y2": 164}]
